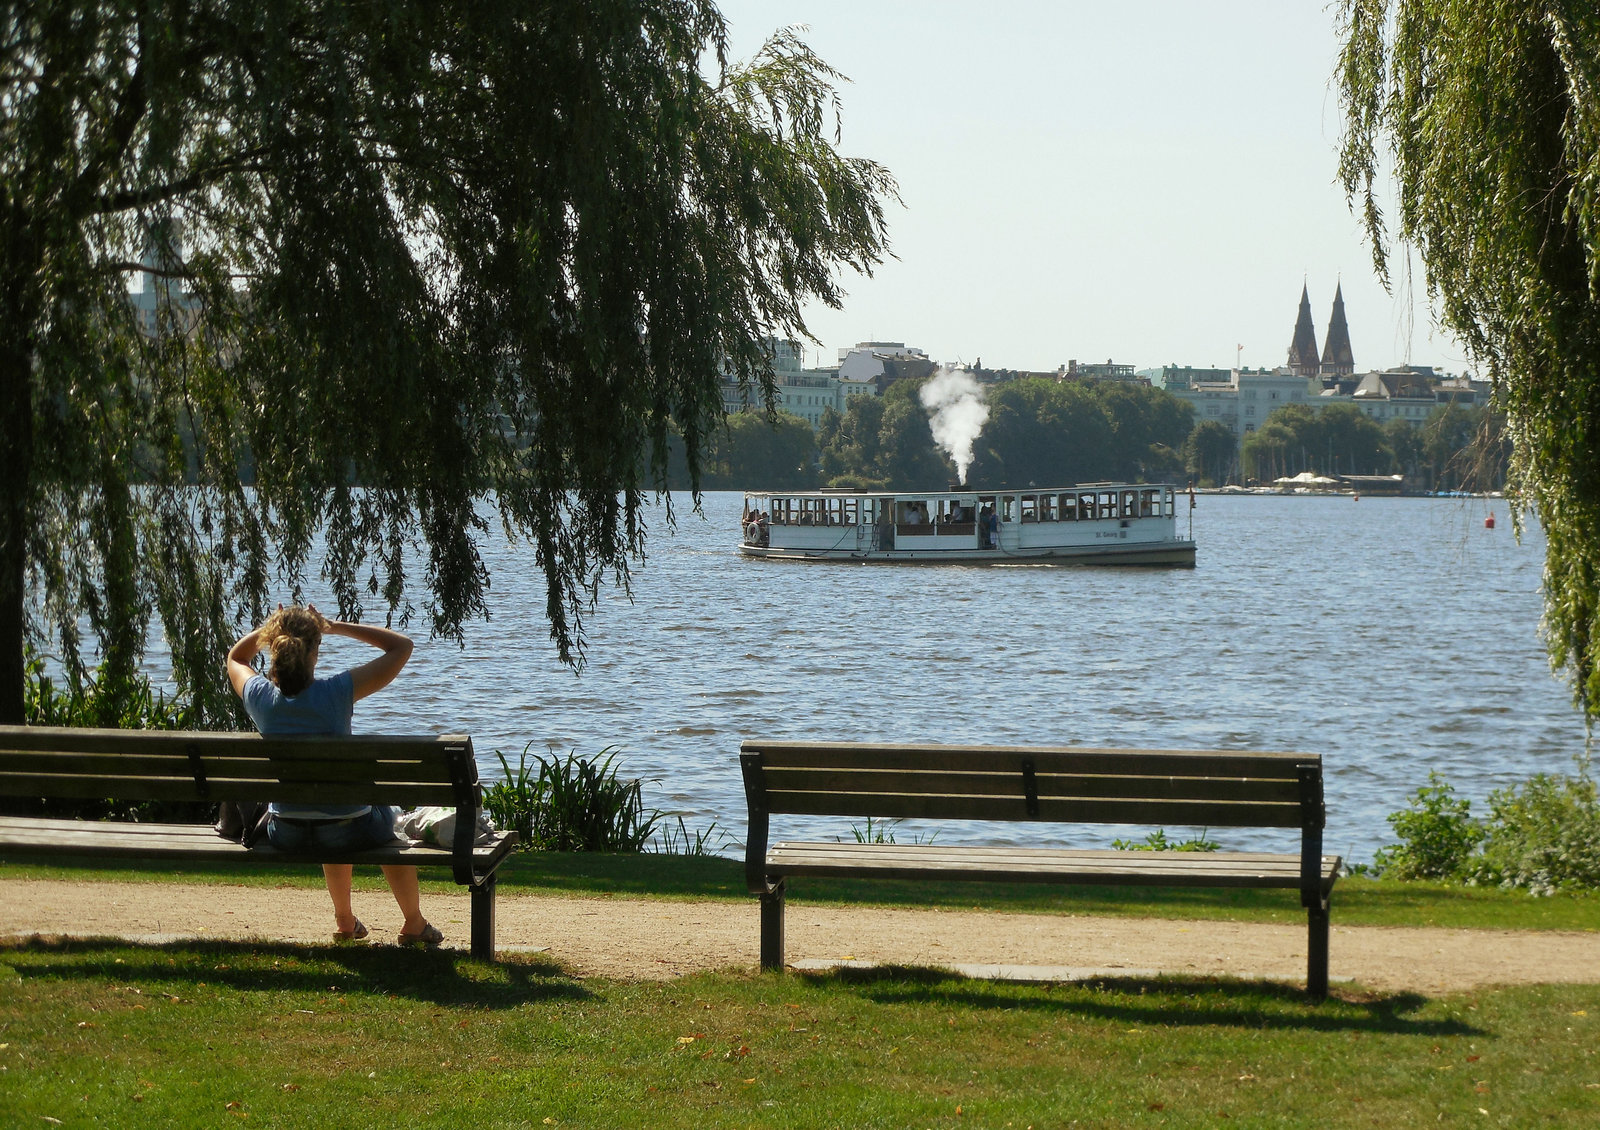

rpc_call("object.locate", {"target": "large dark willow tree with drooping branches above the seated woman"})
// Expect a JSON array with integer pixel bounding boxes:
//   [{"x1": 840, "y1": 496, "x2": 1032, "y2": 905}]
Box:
[{"x1": 0, "y1": 0, "x2": 894, "y2": 723}]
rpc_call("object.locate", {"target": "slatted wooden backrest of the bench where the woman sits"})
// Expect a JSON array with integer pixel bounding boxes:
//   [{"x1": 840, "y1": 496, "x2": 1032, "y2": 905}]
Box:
[{"x1": 0, "y1": 727, "x2": 478, "y2": 811}]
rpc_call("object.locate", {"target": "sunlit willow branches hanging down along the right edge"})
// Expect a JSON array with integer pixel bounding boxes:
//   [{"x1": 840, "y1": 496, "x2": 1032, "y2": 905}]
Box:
[{"x1": 1339, "y1": 0, "x2": 1600, "y2": 720}]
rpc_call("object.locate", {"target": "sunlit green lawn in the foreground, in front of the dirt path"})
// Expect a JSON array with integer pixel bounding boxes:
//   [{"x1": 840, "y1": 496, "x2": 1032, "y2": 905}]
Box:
[{"x1": 0, "y1": 941, "x2": 1600, "y2": 1128}]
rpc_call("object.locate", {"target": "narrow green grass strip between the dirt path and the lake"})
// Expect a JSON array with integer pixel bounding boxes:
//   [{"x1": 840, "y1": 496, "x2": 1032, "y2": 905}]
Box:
[{"x1": 0, "y1": 852, "x2": 1600, "y2": 930}]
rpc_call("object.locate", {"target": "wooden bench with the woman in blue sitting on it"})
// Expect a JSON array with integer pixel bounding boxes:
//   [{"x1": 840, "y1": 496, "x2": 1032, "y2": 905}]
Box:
[{"x1": 0, "y1": 727, "x2": 517, "y2": 960}]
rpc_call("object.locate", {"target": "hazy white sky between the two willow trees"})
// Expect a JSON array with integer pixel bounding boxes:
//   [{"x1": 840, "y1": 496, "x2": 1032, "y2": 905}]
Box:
[{"x1": 720, "y1": 0, "x2": 1467, "y2": 373}]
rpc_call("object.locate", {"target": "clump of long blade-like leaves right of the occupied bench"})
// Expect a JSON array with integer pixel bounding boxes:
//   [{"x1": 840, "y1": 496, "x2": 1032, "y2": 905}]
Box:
[{"x1": 483, "y1": 743, "x2": 661, "y2": 852}]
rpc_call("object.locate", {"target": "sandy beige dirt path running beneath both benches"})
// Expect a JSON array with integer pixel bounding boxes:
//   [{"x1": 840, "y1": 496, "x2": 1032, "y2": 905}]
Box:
[{"x1": 0, "y1": 879, "x2": 1600, "y2": 992}]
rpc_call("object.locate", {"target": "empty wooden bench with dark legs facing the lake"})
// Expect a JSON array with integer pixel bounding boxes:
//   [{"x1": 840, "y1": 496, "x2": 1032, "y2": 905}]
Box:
[{"x1": 739, "y1": 739, "x2": 1339, "y2": 999}]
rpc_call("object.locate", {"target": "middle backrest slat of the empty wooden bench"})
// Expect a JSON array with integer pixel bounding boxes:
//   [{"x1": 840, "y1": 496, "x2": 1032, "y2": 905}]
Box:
[{"x1": 763, "y1": 765, "x2": 1299, "y2": 803}]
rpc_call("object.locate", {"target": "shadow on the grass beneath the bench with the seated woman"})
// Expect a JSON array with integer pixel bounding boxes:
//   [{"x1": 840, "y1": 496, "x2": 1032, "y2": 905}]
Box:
[{"x1": 0, "y1": 938, "x2": 594, "y2": 1010}]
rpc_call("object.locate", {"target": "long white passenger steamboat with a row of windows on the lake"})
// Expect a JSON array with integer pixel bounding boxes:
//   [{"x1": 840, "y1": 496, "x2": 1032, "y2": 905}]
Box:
[{"x1": 739, "y1": 483, "x2": 1195, "y2": 565}]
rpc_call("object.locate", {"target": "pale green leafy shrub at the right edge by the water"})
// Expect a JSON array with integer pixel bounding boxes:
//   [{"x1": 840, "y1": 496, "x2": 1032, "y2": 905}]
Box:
[{"x1": 1469, "y1": 773, "x2": 1600, "y2": 895}]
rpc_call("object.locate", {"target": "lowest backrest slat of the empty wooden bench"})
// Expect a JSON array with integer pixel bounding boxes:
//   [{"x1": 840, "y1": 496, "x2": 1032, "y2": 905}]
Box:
[{"x1": 765, "y1": 789, "x2": 1301, "y2": 827}]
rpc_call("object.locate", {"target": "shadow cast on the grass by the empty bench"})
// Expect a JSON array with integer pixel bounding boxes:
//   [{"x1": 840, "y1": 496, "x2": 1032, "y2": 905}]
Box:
[{"x1": 790, "y1": 965, "x2": 1488, "y2": 1037}]
